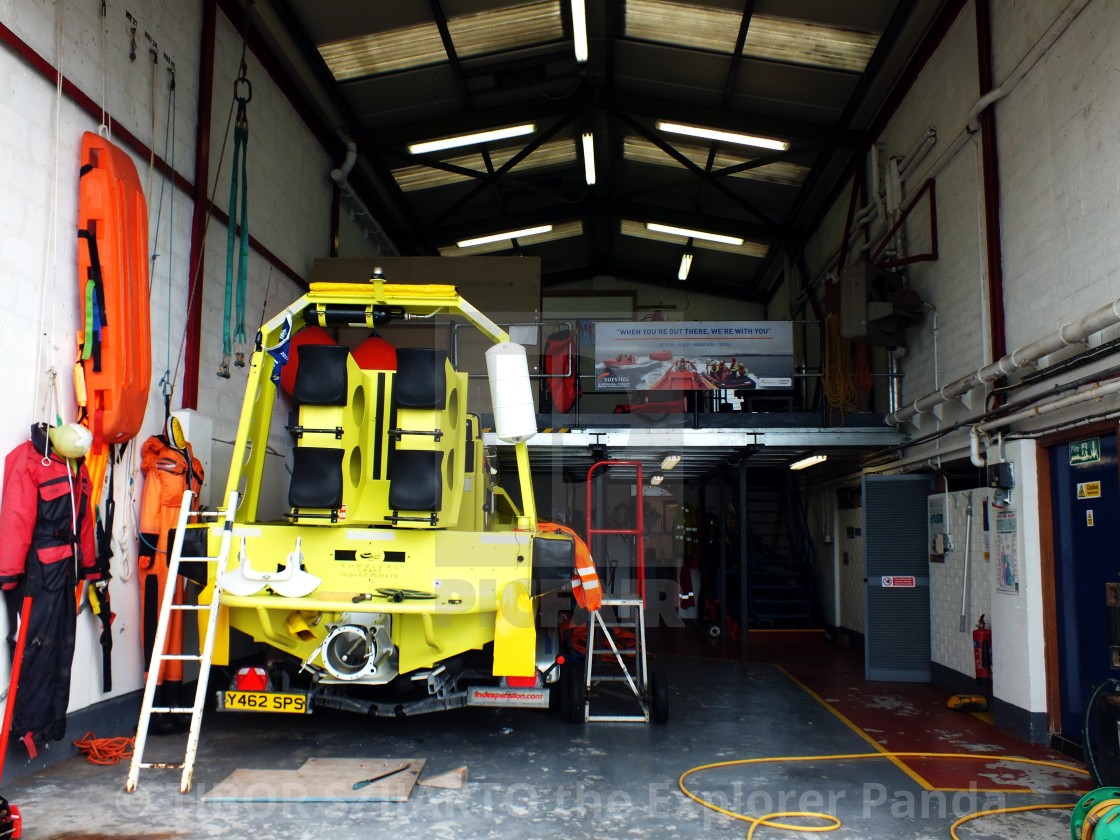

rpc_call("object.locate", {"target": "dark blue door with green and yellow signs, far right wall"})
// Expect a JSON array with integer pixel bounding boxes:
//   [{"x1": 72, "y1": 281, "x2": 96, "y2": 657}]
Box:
[{"x1": 1048, "y1": 435, "x2": 1120, "y2": 740}]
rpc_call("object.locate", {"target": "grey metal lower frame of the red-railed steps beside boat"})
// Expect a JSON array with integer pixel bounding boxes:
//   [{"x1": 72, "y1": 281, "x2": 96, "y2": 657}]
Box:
[{"x1": 584, "y1": 597, "x2": 650, "y2": 724}]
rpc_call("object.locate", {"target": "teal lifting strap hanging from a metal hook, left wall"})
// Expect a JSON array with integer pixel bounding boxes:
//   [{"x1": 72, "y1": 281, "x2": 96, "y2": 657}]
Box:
[{"x1": 217, "y1": 62, "x2": 253, "y2": 379}]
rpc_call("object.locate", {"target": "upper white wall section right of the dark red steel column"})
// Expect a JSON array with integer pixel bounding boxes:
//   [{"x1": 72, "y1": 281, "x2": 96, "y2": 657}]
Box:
[{"x1": 997, "y1": 2, "x2": 1120, "y2": 348}]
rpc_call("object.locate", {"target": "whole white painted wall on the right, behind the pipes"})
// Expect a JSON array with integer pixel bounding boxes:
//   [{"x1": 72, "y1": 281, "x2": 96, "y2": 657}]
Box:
[{"x1": 780, "y1": 0, "x2": 1120, "y2": 725}]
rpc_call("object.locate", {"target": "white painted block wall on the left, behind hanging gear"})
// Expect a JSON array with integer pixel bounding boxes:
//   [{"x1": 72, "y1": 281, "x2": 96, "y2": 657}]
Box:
[{"x1": 0, "y1": 0, "x2": 333, "y2": 725}]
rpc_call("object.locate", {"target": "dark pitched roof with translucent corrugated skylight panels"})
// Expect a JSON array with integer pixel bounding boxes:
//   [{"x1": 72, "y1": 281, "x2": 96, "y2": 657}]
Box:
[{"x1": 273, "y1": 0, "x2": 948, "y2": 304}]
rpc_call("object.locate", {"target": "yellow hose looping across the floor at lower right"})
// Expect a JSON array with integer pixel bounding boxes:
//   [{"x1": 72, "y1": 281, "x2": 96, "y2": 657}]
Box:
[{"x1": 676, "y1": 753, "x2": 1089, "y2": 840}]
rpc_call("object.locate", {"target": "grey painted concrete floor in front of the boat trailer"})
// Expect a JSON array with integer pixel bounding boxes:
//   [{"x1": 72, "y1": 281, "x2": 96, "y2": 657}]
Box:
[{"x1": 4, "y1": 636, "x2": 1085, "y2": 840}]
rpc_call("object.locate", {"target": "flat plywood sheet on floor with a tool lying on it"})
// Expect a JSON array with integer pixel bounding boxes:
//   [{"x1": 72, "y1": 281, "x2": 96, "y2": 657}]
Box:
[{"x1": 203, "y1": 758, "x2": 427, "y2": 802}]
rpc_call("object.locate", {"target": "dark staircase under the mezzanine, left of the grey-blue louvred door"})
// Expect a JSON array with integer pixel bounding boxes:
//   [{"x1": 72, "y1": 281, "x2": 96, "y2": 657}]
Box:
[{"x1": 744, "y1": 469, "x2": 814, "y2": 629}]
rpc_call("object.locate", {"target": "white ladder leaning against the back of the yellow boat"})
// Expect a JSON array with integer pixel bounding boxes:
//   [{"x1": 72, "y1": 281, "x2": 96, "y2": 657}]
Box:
[{"x1": 124, "y1": 491, "x2": 237, "y2": 793}]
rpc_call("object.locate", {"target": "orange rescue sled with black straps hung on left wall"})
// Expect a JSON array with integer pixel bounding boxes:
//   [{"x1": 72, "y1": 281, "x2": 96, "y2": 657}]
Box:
[{"x1": 75, "y1": 132, "x2": 151, "y2": 448}]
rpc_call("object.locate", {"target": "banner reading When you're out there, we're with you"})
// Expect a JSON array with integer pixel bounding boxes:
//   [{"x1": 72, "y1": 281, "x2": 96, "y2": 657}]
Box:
[{"x1": 594, "y1": 320, "x2": 793, "y2": 391}]
